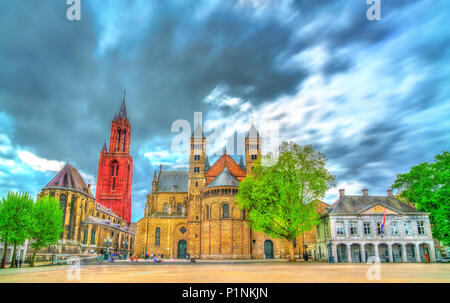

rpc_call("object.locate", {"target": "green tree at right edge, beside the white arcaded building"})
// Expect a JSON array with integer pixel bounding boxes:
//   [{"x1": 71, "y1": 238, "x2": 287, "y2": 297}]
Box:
[{"x1": 392, "y1": 151, "x2": 450, "y2": 246}]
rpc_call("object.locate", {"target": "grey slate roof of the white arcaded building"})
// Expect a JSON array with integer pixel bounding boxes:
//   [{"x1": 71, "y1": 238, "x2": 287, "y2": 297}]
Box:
[{"x1": 329, "y1": 195, "x2": 424, "y2": 214}]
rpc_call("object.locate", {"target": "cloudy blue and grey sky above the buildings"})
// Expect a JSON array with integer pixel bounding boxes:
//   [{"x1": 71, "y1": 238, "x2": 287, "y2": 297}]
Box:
[{"x1": 0, "y1": 0, "x2": 450, "y2": 221}]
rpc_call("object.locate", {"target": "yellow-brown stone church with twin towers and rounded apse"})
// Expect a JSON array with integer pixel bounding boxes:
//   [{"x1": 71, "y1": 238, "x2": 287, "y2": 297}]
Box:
[{"x1": 134, "y1": 124, "x2": 326, "y2": 259}]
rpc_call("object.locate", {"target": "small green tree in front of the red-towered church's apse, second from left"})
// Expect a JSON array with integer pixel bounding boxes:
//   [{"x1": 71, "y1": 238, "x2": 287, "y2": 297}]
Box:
[{"x1": 30, "y1": 195, "x2": 64, "y2": 266}]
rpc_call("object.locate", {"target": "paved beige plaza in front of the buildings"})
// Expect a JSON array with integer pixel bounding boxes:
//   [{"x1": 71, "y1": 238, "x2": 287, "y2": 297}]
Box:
[{"x1": 0, "y1": 262, "x2": 450, "y2": 283}]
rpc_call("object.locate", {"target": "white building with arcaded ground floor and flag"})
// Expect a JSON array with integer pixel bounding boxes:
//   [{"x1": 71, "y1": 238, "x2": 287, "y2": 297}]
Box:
[{"x1": 317, "y1": 189, "x2": 436, "y2": 263}]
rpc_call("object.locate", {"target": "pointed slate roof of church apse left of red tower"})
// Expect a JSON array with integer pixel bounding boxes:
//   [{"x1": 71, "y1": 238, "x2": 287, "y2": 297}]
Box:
[{"x1": 44, "y1": 163, "x2": 92, "y2": 197}]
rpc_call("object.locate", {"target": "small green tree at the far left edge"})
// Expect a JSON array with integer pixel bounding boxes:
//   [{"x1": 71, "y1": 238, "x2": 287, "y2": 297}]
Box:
[{"x1": 0, "y1": 191, "x2": 34, "y2": 268}]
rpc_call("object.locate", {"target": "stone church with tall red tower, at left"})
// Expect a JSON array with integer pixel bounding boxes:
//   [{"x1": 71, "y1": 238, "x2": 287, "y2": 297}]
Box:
[{"x1": 27, "y1": 97, "x2": 135, "y2": 261}]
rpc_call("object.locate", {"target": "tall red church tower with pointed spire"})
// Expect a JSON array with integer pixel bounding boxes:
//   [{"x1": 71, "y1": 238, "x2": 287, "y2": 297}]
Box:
[{"x1": 96, "y1": 93, "x2": 133, "y2": 223}]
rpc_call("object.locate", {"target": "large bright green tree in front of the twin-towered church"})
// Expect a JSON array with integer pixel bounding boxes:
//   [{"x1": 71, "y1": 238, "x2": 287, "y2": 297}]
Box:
[{"x1": 236, "y1": 142, "x2": 335, "y2": 261}]
